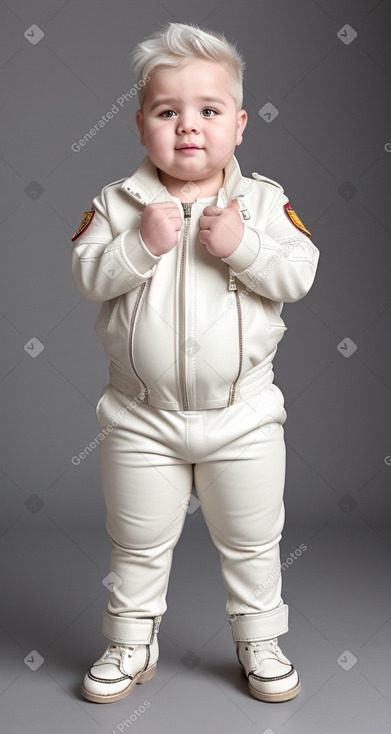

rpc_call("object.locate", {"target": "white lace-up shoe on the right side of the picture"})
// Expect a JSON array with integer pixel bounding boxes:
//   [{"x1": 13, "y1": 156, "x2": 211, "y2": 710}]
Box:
[{"x1": 236, "y1": 637, "x2": 301, "y2": 702}]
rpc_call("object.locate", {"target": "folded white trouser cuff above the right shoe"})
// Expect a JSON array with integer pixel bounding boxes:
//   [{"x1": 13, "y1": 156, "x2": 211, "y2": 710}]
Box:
[{"x1": 228, "y1": 604, "x2": 289, "y2": 642}]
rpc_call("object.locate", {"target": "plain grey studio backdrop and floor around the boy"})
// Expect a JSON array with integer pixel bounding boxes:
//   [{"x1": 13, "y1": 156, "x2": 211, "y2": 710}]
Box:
[{"x1": 0, "y1": 0, "x2": 391, "y2": 734}]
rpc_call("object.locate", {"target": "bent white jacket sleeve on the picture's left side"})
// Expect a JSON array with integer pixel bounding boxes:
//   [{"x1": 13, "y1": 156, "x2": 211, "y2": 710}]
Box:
[{"x1": 72, "y1": 194, "x2": 162, "y2": 301}]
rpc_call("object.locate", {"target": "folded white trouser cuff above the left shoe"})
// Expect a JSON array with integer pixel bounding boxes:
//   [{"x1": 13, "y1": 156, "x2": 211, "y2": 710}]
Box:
[{"x1": 102, "y1": 609, "x2": 161, "y2": 645}]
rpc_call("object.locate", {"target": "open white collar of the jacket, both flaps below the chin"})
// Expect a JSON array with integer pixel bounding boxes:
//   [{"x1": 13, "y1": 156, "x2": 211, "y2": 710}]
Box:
[{"x1": 121, "y1": 155, "x2": 254, "y2": 206}]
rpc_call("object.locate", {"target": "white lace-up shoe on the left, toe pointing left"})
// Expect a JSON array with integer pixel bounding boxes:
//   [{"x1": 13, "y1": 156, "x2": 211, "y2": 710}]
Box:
[{"x1": 80, "y1": 634, "x2": 159, "y2": 703}]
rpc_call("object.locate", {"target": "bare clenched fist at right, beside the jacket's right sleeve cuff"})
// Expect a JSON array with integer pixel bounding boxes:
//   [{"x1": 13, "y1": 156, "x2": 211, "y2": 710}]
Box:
[{"x1": 198, "y1": 199, "x2": 244, "y2": 257}]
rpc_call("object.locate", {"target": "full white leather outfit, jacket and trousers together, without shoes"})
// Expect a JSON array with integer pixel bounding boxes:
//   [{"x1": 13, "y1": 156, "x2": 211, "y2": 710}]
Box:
[{"x1": 72, "y1": 156, "x2": 319, "y2": 642}]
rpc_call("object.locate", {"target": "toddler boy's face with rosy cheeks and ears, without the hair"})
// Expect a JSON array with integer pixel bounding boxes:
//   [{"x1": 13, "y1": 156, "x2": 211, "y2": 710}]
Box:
[{"x1": 136, "y1": 59, "x2": 247, "y2": 188}]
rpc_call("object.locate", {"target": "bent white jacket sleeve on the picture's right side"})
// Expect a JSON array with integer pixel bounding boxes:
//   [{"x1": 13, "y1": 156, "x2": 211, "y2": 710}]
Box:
[{"x1": 221, "y1": 186, "x2": 320, "y2": 303}]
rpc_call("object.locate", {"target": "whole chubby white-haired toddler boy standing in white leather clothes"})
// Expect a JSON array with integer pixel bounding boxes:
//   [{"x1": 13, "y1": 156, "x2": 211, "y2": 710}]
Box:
[{"x1": 72, "y1": 23, "x2": 319, "y2": 703}]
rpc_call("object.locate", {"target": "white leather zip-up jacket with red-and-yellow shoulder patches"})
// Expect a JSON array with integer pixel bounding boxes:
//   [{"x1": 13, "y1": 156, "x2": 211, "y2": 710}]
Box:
[{"x1": 72, "y1": 156, "x2": 320, "y2": 410}]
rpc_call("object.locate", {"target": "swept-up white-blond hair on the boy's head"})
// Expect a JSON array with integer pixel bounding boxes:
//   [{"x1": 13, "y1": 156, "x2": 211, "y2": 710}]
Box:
[{"x1": 129, "y1": 23, "x2": 246, "y2": 111}]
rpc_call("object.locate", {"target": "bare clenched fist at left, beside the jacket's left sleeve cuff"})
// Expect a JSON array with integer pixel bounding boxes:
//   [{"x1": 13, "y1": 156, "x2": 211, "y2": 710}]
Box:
[{"x1": 140, "y1": 201, "x2": 182, "y2": 256}]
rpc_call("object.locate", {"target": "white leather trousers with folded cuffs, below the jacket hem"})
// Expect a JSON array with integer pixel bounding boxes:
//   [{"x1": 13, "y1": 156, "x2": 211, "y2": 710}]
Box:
[{"x1": 96, "y1": 383, "x2": 288, "y2": 642}]
